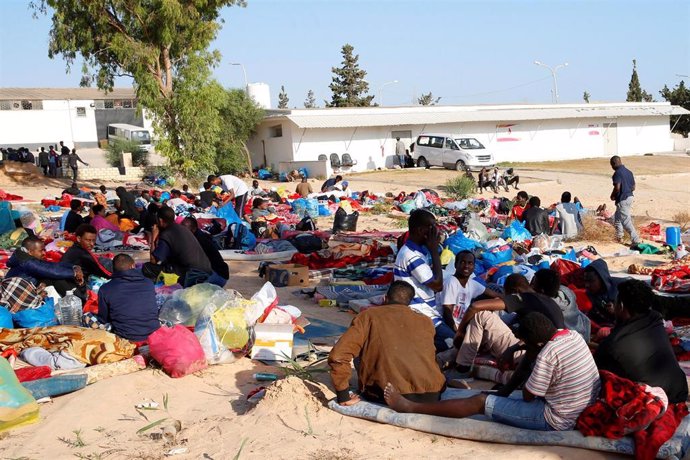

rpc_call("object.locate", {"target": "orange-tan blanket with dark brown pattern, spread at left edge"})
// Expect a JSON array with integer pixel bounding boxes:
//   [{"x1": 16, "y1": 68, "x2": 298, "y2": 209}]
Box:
[{"x1": 0, "y1": 326, "x2": 136, "y2": 365}]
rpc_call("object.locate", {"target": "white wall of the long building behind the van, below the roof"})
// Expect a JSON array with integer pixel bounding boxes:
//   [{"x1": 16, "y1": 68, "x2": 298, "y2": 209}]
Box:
[{"x1": 248, "y1": 116, "x2": 673, "y2": 171}]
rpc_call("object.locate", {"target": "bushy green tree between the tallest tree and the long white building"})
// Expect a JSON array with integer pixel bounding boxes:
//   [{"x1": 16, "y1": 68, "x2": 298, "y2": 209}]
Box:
[{"x1": 212, "y1": 89, "x2": 264, "y2": 174}]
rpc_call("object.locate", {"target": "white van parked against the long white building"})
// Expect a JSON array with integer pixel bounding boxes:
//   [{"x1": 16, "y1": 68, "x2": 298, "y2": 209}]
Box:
[{"x1": 412, "y1": 133, "x2": 494, "y2": 171}]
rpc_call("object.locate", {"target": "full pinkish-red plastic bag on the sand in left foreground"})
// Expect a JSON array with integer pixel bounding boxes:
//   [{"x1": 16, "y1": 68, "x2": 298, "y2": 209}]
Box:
[{"x1": 148, "y1": 324, "x2": 208, "y2": 378}]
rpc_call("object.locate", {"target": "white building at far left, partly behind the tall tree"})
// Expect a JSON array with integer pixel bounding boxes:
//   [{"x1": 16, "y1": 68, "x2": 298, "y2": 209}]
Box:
[{"x1": 0, "y1": 88, "x2": 151, "y2": 149}]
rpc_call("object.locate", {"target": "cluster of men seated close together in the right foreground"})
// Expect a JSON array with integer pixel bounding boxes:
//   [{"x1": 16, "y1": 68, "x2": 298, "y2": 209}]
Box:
[{"x1": 328, "y1": 209, "x2": 688, "y2": 431}]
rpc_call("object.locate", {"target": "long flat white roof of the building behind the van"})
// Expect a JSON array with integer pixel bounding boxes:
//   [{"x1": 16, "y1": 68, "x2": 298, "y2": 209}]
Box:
[{"x1": 265, "y1": 102, "x2": 690, "y2": 128}]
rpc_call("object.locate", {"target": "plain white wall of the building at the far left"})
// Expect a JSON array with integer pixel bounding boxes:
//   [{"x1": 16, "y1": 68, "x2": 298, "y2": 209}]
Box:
[{"x1": 0, "y1": 100, "x2": 98, "y2": 148}]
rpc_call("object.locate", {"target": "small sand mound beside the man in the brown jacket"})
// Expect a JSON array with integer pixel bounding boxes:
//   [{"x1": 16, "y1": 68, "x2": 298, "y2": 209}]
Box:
[{"x1": 255, "y1": 377, "x2": 334, "y2": 413}]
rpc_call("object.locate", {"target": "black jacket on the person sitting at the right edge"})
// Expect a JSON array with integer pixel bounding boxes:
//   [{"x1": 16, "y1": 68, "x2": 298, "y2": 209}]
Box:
[{"x1": 594, "y1": 310, "x2": 688, "y2": 403}]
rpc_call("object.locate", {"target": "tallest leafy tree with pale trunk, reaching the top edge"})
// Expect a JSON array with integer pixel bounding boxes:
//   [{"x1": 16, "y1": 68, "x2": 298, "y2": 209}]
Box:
[{"x1": 31, "y1": 0, "x2": 245, "y2": 176}]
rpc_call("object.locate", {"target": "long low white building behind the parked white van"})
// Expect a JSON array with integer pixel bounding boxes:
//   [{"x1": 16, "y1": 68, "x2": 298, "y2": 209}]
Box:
[{"x1": 248, "y1": 102, "x2": 690, "y2": 176}]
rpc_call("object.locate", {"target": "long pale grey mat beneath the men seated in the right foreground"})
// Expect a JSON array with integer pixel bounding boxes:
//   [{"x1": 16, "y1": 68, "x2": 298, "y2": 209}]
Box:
[{"x1": 328, "y1": 390, "x2": 690, "y2": 459}]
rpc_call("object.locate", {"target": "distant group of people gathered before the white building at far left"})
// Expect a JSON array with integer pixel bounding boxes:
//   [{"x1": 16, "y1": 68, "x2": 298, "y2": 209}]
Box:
[{"x1": 0, "y1": 141, "x2": 89, "y2": 181}]
